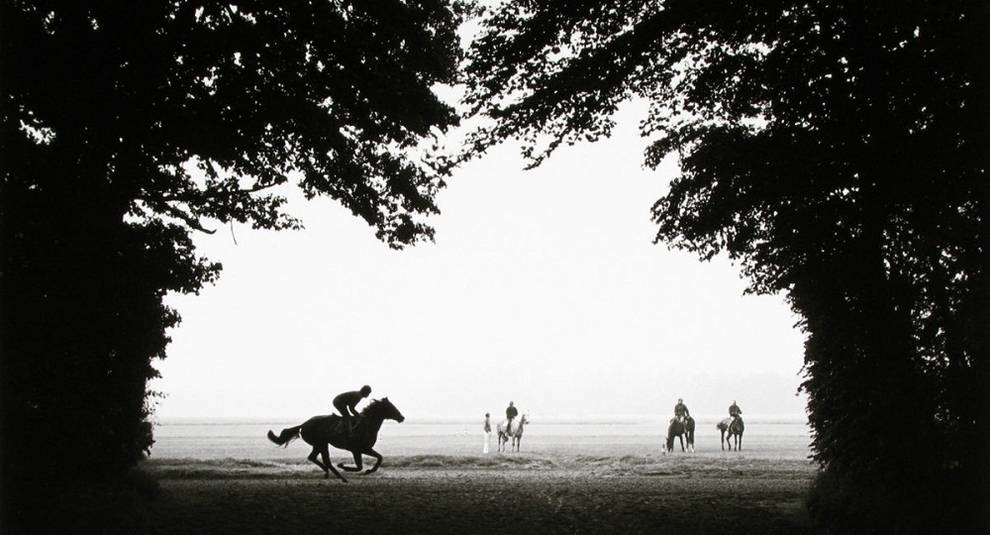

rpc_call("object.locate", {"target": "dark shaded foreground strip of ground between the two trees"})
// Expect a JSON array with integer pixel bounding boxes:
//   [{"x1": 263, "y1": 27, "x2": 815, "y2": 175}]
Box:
[{"x1": 143, "y1": 451, "x2": 815, "y2": 535}]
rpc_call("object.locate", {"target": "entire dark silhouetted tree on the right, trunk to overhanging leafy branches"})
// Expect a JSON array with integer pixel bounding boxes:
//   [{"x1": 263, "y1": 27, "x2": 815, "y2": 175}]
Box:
[{"x1": 466, "y1": 0, "x2": 990, "y2": 532}]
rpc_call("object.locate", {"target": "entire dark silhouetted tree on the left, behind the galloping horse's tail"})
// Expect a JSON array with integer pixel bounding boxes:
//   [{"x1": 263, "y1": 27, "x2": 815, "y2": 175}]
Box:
[{"x1": 0, "y1": 0, "x2": 461, "y2": 528}]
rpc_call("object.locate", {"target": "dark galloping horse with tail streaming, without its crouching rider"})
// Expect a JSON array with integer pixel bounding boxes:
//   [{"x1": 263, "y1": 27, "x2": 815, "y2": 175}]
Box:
[{"x1": 268, "y1": 398, "x2": 405, "y2": 483}]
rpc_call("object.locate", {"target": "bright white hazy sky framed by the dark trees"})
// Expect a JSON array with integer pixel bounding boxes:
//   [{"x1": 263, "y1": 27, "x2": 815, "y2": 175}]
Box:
[{"x1": 152, "y1": 105, "x2": 805, "y2": 420}]
